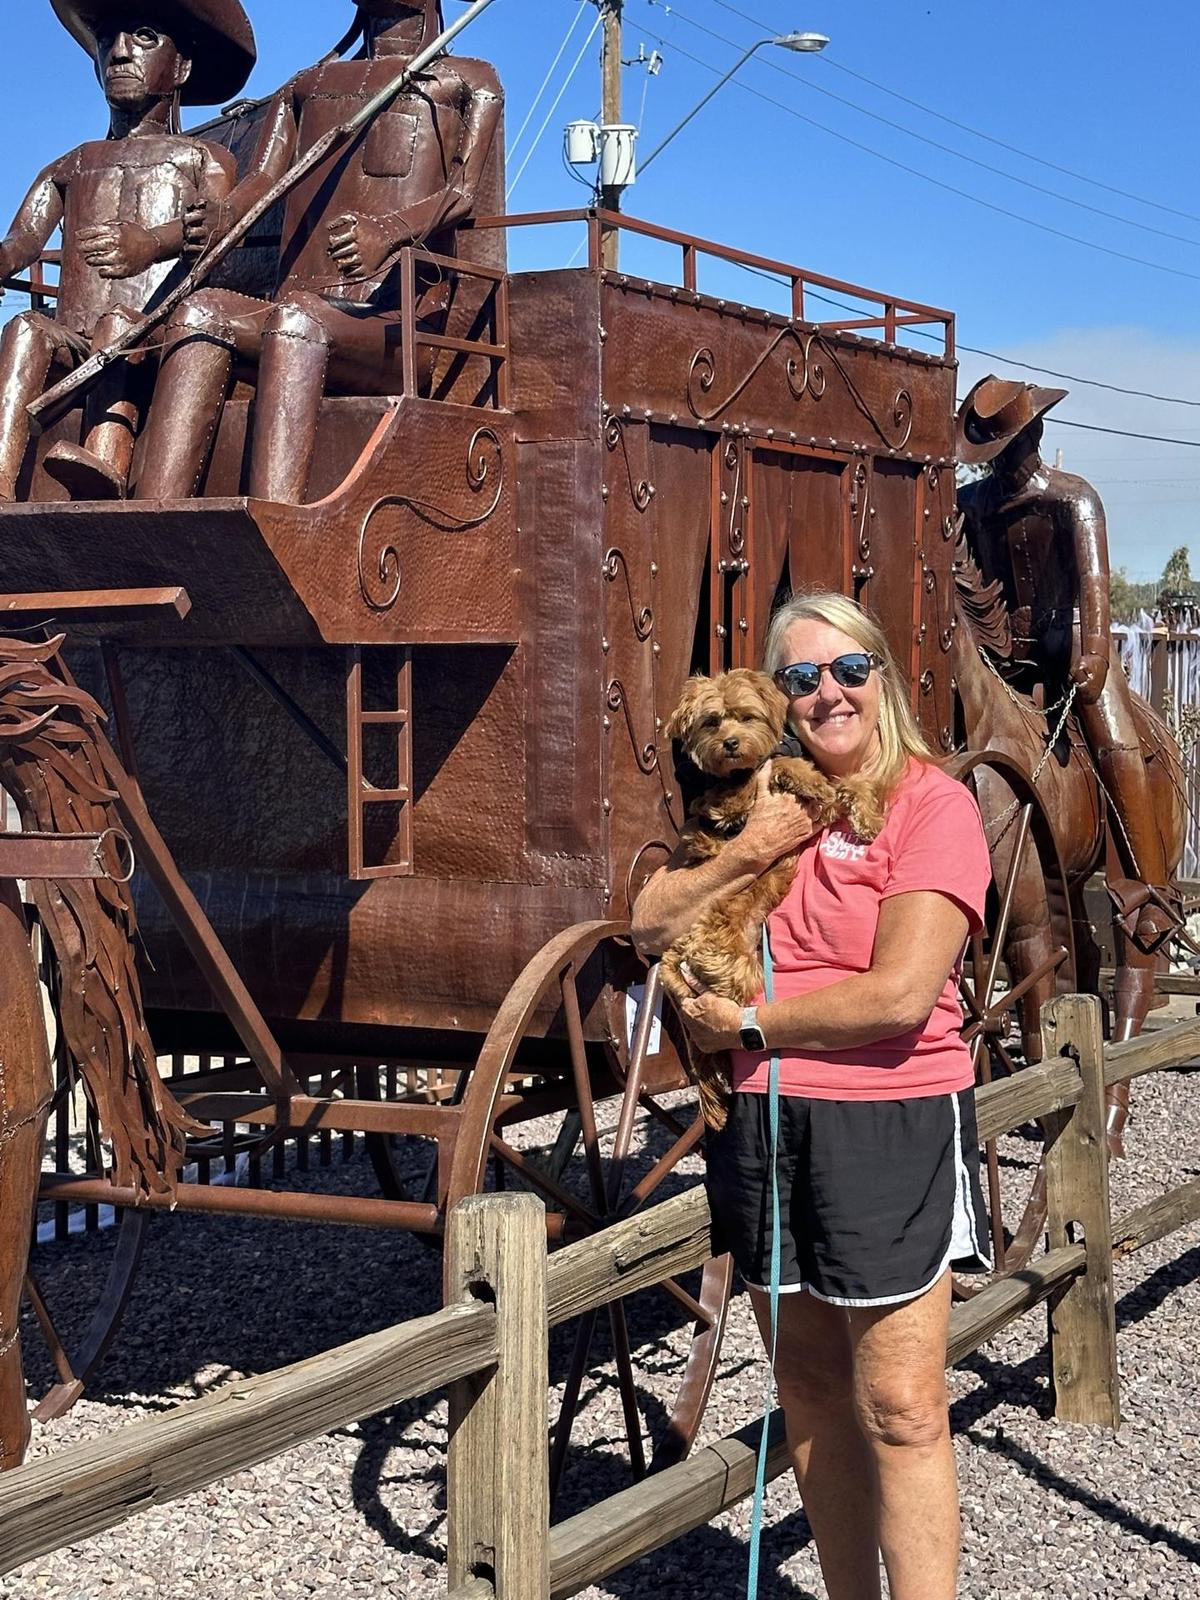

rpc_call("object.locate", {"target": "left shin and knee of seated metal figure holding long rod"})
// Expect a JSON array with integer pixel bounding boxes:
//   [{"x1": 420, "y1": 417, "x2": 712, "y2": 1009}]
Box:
[{"x1": 136, "y1": 290, "x2": 235, "y2": 499}]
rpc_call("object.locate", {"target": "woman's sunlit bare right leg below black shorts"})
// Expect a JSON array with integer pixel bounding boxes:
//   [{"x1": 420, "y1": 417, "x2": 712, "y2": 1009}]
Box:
[{"x1": 851, "y1": 1272, "x2": 960, "y2": 1600}]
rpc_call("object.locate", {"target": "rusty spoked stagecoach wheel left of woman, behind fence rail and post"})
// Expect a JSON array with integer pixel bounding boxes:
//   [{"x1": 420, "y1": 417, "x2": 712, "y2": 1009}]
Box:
[{"x1": 448, "y1": 922, "x2": 733, "y2": 1493}]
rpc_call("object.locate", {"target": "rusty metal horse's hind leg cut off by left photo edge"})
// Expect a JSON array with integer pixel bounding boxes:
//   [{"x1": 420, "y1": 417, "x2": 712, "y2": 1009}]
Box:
[{"x1": 0, "y1": 882, "x2": 53, "y2": 1470}]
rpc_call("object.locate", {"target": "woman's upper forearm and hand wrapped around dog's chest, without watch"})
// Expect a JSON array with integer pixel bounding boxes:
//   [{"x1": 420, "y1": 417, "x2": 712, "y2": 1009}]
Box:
[{"x1": 634, "y1": 762, "x2": 813, "y2": 957}]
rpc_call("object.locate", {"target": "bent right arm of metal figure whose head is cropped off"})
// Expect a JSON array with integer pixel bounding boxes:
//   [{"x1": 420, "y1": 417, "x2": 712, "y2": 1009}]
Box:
[{"x1": 330, "y1": 61, "x2": 504, "y2": 277}]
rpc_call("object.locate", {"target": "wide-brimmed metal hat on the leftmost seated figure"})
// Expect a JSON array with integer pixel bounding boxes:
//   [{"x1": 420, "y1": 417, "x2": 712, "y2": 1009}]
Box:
[{"x1": 50, "y1": 0, "x2": 258, "y2": 106}]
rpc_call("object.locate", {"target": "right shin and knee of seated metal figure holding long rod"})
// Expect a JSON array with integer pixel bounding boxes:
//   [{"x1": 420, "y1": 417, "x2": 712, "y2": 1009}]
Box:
[{"x1": 250, "y1": 294, "x2": 330, "y2": 506}]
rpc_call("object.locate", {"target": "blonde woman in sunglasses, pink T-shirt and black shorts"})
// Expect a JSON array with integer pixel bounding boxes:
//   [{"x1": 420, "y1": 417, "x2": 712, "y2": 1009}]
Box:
[{"x1": 634, "y1": 594, "x2": 990, "y2": 1600}]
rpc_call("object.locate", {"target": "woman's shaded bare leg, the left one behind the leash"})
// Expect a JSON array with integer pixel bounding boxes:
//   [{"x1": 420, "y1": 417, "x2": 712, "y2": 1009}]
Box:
[{"x1": 750, "y1": 1290, "x2": 880, "y2": 1600}]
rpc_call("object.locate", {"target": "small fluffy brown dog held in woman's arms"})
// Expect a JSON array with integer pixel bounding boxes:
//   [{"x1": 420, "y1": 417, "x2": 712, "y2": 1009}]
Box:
[{"x1": 662, "y1": 667, "x2": 883, "y2": 1128}]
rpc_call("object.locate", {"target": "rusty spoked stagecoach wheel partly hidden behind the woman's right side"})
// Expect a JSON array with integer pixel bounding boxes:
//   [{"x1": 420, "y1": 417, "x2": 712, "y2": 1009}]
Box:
[{"x1": 950, "y1": 750, "x2": 1077, "y2": 1299}]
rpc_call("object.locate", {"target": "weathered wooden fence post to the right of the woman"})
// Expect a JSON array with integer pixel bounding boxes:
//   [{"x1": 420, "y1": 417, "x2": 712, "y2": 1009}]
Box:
[{"x1": 1042, "y1": 995, "x2": 1120, "y2": 1429}]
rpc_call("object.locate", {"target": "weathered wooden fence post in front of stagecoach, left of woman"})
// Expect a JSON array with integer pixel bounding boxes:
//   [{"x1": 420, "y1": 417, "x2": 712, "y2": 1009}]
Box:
[{"x1": 446, "y1": 1194, "x2": 550, "y2": 1600}]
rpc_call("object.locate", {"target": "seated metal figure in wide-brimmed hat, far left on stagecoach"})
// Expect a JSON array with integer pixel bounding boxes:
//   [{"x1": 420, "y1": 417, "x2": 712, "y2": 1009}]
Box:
[{"x1": 0, "y1": 0, "x2": 254, "y2": 501}]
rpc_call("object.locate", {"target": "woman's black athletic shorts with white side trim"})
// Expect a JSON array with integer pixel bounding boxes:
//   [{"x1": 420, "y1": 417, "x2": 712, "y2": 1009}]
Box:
[{"x1": 706, "y1": 1090, "x2": 992, "y2": 1306}]
